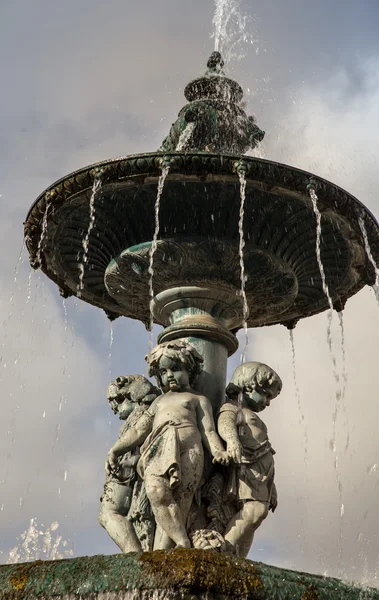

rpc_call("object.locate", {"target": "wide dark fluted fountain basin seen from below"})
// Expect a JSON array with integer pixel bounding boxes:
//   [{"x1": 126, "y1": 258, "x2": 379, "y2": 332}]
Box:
[{"x1": 25, "y1": 152, "x2": 379, "y2": 326}]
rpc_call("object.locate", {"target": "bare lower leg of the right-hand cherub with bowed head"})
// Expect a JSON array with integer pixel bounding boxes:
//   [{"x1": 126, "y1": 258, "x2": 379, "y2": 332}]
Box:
[{"x1": 224, "y1": 500, "x2": 268, "y2": 558}]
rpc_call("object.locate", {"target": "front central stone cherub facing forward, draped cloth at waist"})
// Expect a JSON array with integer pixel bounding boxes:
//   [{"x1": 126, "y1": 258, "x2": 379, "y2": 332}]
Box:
[{"x1": 107, "y1": 340, "x2": 228, "y2": 550}]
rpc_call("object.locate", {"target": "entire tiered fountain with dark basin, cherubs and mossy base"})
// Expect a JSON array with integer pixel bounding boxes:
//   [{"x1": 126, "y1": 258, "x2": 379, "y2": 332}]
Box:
[{"x1": 0, "y1": 52, "x2": 379, "y2": 599}]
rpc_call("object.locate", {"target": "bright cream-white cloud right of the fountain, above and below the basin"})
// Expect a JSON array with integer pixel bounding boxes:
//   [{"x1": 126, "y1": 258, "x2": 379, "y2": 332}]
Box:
[{"x1": 246, "y1": 61, "x2": 379, "y2": 585}]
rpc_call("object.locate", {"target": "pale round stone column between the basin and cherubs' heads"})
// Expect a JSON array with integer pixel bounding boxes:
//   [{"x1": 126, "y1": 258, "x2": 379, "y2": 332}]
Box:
[{"x1": 152, "y1": 285, "x2": 243, "y2": 412}]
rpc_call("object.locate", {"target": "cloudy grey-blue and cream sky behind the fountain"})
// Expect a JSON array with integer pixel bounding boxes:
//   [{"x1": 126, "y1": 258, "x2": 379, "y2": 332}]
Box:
[{"x1": 0, "y1": 0, "x2": 379, "y2": 587}]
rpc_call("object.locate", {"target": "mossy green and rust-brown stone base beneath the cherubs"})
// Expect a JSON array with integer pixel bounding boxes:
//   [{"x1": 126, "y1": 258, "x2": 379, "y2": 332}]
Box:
[{"x1": 0, "y1": 549, "x2": 379, "y2": 600}]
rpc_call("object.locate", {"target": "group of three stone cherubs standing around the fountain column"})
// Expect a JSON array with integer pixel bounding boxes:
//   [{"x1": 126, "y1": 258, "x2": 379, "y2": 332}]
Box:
[{"x1": 100, "y1": 340, "x2": 282, "y2": 557}]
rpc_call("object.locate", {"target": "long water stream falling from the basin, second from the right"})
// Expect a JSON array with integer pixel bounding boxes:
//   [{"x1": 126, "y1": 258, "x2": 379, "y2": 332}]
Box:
[{"x1": 309, "y1": 188, "x2": 346, "y2": 563}]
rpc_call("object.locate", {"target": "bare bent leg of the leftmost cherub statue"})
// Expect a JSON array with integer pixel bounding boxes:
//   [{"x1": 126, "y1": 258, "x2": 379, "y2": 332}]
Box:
[{"x1": 99, "y1": 482, "x2": 142, "y2": 554}]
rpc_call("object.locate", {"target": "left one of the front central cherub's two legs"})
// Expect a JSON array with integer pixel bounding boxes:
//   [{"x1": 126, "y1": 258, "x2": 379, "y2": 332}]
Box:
[{"x1": 145, "y1": 473, "x2": 191, "y2": 550}]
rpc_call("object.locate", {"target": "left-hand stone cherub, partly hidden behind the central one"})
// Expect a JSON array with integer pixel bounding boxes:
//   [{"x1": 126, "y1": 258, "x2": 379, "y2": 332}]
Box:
[{"x1": 99, "y1": 375, "x2": 161, "y2": 553}]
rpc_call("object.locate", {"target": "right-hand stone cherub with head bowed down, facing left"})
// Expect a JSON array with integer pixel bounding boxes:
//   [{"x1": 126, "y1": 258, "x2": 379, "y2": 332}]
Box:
[{"x1": 218, "y1": 362, "x2": 282, "y2": 557}]
